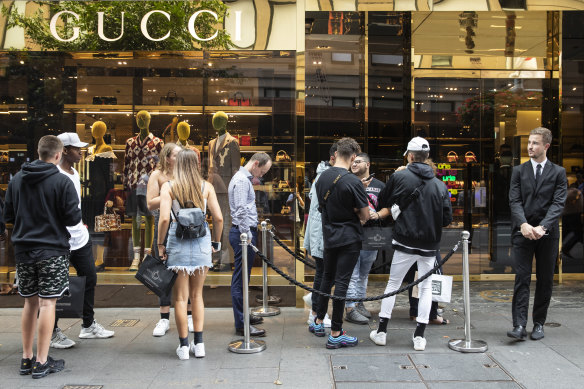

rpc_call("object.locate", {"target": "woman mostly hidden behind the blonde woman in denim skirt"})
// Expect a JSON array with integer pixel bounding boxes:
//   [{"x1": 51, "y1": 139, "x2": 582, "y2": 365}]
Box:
[{"x1": 146, "y1": 143, "x2": 182, "y2": 336}]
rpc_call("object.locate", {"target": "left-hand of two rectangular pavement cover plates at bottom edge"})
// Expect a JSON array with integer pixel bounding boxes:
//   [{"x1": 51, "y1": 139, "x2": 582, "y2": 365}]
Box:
[{"x1": 331, "y1": 354, "x2": 421, "y2": 382}]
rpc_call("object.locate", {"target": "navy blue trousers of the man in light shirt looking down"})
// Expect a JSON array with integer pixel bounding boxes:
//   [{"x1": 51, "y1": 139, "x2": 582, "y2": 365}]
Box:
[{"x1": 229, "y1": 227, "x2": 258, "y2": 329}]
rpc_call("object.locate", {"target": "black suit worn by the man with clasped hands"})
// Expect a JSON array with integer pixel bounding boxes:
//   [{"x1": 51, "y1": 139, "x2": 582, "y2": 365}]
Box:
[{"x1": 509, "y1": 160, "x2": 568, "y2": 327}]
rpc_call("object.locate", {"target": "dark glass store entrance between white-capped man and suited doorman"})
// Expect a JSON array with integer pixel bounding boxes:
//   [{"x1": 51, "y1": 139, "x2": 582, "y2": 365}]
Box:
[{"x1": 413, "y1": 70, "x2": 545, "y2": 274}]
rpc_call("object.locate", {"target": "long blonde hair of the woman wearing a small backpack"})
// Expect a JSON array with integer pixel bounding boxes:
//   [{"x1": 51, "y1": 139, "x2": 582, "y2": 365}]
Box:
[{"x1": 172, "y1": 149, "x2": 204, "y2": 209}]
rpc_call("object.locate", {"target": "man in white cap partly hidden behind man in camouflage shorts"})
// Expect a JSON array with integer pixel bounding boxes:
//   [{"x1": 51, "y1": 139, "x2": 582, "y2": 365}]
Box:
[{"x1": 51, "y1": 132, "x2": 114, "y2": 348}]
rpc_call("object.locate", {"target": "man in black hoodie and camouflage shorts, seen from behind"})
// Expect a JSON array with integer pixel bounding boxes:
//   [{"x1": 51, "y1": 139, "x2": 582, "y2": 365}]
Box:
[{"x1": 4, "y1": 135, "x2": 81, "y2": 378}]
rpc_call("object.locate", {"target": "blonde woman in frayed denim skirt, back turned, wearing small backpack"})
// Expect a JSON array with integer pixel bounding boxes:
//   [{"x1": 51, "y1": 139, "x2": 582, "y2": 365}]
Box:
[{"x1": 158, "y1": 149, "x2": 223, "y2": 360}]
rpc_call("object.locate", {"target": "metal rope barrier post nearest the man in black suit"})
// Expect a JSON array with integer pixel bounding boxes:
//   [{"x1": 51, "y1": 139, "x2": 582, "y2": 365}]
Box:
[{"x1": 448, "y1": 231, "x2": 489, "y2": 353}]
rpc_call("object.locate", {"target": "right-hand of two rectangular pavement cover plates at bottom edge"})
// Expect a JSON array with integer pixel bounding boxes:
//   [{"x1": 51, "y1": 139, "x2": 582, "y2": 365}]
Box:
[{"x1": 410, "y1": 352, "x2": 511, "y2": 381}]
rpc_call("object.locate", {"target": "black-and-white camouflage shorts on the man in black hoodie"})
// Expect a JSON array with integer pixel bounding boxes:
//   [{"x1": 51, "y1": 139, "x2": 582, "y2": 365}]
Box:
[{"x1": 16, "y1": 255, "x2": 69, "y2": 298}]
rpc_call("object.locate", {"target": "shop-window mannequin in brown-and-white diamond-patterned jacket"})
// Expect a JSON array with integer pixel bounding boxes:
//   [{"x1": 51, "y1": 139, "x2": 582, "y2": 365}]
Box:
[{"x1": 124, "y1": 111, "x2": 164, "y2": 271}]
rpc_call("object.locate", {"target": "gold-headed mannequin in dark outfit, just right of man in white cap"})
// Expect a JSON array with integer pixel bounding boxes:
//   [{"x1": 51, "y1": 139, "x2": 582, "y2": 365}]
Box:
[{"x1": 85, "y1": 121, "x2": 117, "y2": 272}]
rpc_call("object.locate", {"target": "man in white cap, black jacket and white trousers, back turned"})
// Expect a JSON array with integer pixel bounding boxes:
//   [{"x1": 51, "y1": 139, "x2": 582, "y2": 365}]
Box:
[{"x1": 369, "y1": 137, "x2": 452, "y2": 351}]
